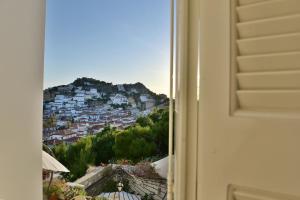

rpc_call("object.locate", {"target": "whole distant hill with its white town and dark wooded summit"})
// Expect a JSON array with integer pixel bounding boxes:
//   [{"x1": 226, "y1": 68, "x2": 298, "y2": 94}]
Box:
[{"x1": 43, "y1": 78, "x2": 168, "y2": 146}]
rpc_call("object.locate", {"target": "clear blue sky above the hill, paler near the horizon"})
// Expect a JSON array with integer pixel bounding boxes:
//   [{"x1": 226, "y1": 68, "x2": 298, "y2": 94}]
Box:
[{"x1": 44, "y1": 0, "x2": 170, "y2": 94}]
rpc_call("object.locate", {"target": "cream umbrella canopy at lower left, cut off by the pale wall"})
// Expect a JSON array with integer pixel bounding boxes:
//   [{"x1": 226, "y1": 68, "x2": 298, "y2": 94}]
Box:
[{"x1": 43, "y1": 151, "x2": 70, "y2": 172}]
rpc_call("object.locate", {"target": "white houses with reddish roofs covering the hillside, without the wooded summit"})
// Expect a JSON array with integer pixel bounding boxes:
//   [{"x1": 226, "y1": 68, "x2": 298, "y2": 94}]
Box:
[{"x1": 43, "y1": 86, "x2": 156, "y2": 146}]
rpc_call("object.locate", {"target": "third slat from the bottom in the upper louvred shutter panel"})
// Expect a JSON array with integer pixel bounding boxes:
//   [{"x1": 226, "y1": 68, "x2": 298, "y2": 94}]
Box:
[{"x1": 237, "y1": 52, "x2": 300, "y2": 72}]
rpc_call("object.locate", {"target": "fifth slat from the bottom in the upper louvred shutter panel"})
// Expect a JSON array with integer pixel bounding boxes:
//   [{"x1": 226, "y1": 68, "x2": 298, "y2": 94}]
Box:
[{"x1": 237, "y1": 15, "x2": 300, "y2": 38}]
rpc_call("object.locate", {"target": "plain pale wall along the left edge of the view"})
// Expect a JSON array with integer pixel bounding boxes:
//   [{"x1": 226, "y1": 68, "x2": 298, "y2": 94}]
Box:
[{"x1": 0, "y1": 0, "x2": 44, "y2": 200}]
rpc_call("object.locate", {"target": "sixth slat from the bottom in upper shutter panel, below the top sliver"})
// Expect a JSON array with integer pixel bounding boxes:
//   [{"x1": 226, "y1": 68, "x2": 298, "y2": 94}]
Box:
[{"x1": 237, "y1": 0, "x2": 300, "y2": 22}]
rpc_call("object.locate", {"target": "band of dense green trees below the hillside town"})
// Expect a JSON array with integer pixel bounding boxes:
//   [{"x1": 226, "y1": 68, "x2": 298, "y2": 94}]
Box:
[{"x1": 53, "y1": 110, "x2": 169, "y2": 181}]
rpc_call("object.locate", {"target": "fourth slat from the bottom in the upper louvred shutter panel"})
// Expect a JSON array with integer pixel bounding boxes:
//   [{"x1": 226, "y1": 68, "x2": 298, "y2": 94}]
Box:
[{"x1": 237, "y1": 32, "x2": 300, "y2": 55}]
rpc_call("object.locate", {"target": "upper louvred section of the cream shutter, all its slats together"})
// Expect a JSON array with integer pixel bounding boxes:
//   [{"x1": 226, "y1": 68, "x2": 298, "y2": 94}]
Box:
[{"x1": 231, "y1": 0, "x2": 300, "y2": 111}]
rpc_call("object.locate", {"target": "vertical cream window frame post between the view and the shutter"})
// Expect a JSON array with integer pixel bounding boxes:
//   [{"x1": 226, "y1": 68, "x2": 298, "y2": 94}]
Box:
[{"x1": 174, "y1": 0, "x2": 200, "y2": 200}]
